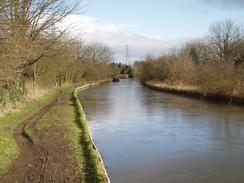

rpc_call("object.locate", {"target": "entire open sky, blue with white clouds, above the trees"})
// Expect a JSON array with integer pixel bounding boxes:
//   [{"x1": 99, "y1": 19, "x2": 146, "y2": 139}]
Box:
[{"x1": 62, "y1": 0, "x2": 244, "y2": 62}]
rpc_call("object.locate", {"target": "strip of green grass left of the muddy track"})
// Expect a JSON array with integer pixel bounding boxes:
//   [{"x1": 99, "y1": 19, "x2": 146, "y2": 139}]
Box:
[{"x1": 0, "y1": 88, "x2": 59, "y2": 174}]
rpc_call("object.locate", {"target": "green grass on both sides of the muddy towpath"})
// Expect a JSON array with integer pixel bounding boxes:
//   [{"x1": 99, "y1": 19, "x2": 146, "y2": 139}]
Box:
[{"x1": 0, "y1": 84, "x2": 107, "y2": 183}]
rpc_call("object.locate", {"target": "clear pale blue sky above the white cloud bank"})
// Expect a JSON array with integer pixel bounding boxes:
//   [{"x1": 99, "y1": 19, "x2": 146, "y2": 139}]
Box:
[{"x1": 87, "y1": 0, "x2": 244, "y2": 38}]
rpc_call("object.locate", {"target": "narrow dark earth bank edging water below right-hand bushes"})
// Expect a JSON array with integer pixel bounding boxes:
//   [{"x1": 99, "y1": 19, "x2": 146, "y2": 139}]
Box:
[{"x1": 142, "y1": 81, "x2": 244, "y2": 105}]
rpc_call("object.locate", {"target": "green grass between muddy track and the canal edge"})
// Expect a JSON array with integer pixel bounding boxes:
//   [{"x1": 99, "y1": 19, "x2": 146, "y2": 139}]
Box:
[{"x1": 26, "y1": 87, "x2": 107, "y2": 183}]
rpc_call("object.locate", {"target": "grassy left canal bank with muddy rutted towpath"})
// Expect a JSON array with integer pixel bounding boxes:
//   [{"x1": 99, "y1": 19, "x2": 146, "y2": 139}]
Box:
[{"x1": 0, "y1": 81, "x2": 108, "y2": 183}]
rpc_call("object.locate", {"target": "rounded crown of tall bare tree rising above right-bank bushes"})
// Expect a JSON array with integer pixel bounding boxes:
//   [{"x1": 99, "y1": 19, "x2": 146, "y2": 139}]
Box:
[{"x1": 209, "y1": 20, "x2": 243, "y2": 60}]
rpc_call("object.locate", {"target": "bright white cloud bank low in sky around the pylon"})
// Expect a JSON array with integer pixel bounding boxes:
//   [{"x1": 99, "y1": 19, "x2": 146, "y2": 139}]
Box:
[{"x1": 58, "y1": 15, "x2": 189, "y2": 62}]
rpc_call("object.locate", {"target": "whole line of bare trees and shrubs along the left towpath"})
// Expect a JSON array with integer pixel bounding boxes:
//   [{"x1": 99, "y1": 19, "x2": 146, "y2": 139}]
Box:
[{"x1": 0, "y1": 0, "x2": 113, "y2": 112}]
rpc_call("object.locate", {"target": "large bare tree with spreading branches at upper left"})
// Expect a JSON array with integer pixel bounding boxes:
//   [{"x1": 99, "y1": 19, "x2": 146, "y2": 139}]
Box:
[{"x1": 0, "y1": 0, "x2": 83, "y2": 87}]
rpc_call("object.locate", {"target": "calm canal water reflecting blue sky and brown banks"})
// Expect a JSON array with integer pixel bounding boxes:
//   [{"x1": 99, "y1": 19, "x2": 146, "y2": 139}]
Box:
[{"x1": 77, "y1": 80, "x2": 244, "y2": 183}]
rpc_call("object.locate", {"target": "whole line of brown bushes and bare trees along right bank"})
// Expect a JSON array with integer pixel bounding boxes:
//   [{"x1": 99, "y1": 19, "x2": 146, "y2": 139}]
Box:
[{"x1": 135, "y1": 20, "x2": 244, "y2": 97}]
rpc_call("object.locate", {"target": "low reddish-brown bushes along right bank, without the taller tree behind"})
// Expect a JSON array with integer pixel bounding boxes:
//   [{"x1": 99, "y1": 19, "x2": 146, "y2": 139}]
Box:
[{"x1": 135, "y1": 55, "x2": 244, "y2": 96}]
